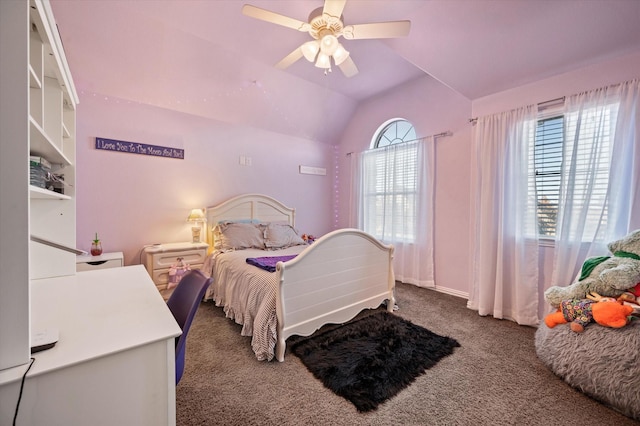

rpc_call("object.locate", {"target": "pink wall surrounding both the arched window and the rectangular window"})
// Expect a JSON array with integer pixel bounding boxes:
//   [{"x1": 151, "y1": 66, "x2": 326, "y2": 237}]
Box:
[{"x1": 337, "y1": 54, "x2": 640, "y2": 300}]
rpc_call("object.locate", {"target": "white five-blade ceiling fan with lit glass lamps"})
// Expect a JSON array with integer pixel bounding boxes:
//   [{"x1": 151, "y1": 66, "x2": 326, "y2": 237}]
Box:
[{"x1": 242, "y1": 0, "x2": 411, "y2": 77}]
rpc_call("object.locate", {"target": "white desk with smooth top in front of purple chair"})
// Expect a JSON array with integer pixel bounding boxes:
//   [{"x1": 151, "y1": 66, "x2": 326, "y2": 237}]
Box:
[{"x1": 0, "y1": 265, "x2": 181, "y2": 426}]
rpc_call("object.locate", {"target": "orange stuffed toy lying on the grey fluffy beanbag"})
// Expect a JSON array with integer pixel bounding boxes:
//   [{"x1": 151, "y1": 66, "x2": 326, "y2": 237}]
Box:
[{"x1": 544, "y1": 293, "x2": 633, "y2": 333}]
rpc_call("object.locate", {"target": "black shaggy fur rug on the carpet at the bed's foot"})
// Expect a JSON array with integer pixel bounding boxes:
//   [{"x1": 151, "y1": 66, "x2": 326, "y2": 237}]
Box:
[{"x1": 290, "y1": 311, "x2": 460, "y2": 412}]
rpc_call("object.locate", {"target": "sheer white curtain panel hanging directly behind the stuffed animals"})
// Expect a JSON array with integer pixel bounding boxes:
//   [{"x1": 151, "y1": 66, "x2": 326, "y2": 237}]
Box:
[{"x1": 551, "y1": 80, "x2": 640, "y2": 286}]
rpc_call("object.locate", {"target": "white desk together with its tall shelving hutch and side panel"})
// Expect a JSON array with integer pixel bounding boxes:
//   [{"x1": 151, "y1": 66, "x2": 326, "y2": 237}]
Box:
[{"x1": 0, "y1": 0, "x2": 180, "y2": 426}]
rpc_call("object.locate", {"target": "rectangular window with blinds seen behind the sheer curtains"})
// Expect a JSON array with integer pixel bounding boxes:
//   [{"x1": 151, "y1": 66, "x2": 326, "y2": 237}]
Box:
[{"x1": 529, "y1": 104, "x2": 617, "y2": 241}]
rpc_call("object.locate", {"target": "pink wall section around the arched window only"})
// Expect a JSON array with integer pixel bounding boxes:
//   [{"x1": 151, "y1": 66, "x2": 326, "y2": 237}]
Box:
[{"x1": 338, "y1": 77, "x2": 471, "y2": 296}]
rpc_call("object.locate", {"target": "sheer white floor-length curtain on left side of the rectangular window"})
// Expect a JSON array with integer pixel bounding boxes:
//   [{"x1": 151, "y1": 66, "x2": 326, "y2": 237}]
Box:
[{"x1": 467, "y1": 106, "x2": 538, "y2": 325}]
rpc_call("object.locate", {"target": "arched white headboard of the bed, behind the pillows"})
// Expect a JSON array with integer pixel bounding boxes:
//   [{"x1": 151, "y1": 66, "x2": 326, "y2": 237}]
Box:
[{"x1": 206, "y1": 194, "x2": 296, "y2": 245}]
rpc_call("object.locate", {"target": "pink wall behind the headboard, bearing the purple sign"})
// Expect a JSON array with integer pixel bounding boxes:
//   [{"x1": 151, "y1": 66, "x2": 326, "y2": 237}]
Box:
[{"x1": 76, "y1": 92, "x2": 334, "y2": 265}]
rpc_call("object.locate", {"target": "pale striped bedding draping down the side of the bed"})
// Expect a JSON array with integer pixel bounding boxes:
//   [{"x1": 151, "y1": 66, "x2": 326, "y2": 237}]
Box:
[{"x1": 202, "y1": 245, "x2": 307, "y2": 361}]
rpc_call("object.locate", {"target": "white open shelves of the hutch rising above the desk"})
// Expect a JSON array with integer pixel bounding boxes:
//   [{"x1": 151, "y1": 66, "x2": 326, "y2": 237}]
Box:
[{"x1": 26, "y1": 0, "x2": 78, "y2": 280}]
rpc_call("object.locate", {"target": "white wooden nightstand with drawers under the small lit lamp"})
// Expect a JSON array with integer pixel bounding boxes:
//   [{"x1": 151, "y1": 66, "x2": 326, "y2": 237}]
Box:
[{"x1": 143, "y1": 243, "x2": 209, "y2": 300}]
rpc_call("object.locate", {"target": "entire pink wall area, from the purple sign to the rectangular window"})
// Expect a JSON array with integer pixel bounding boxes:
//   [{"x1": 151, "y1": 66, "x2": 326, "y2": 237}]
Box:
[{"x1": 77, "y1": 54, "x2": 640, "y2": 296}]
